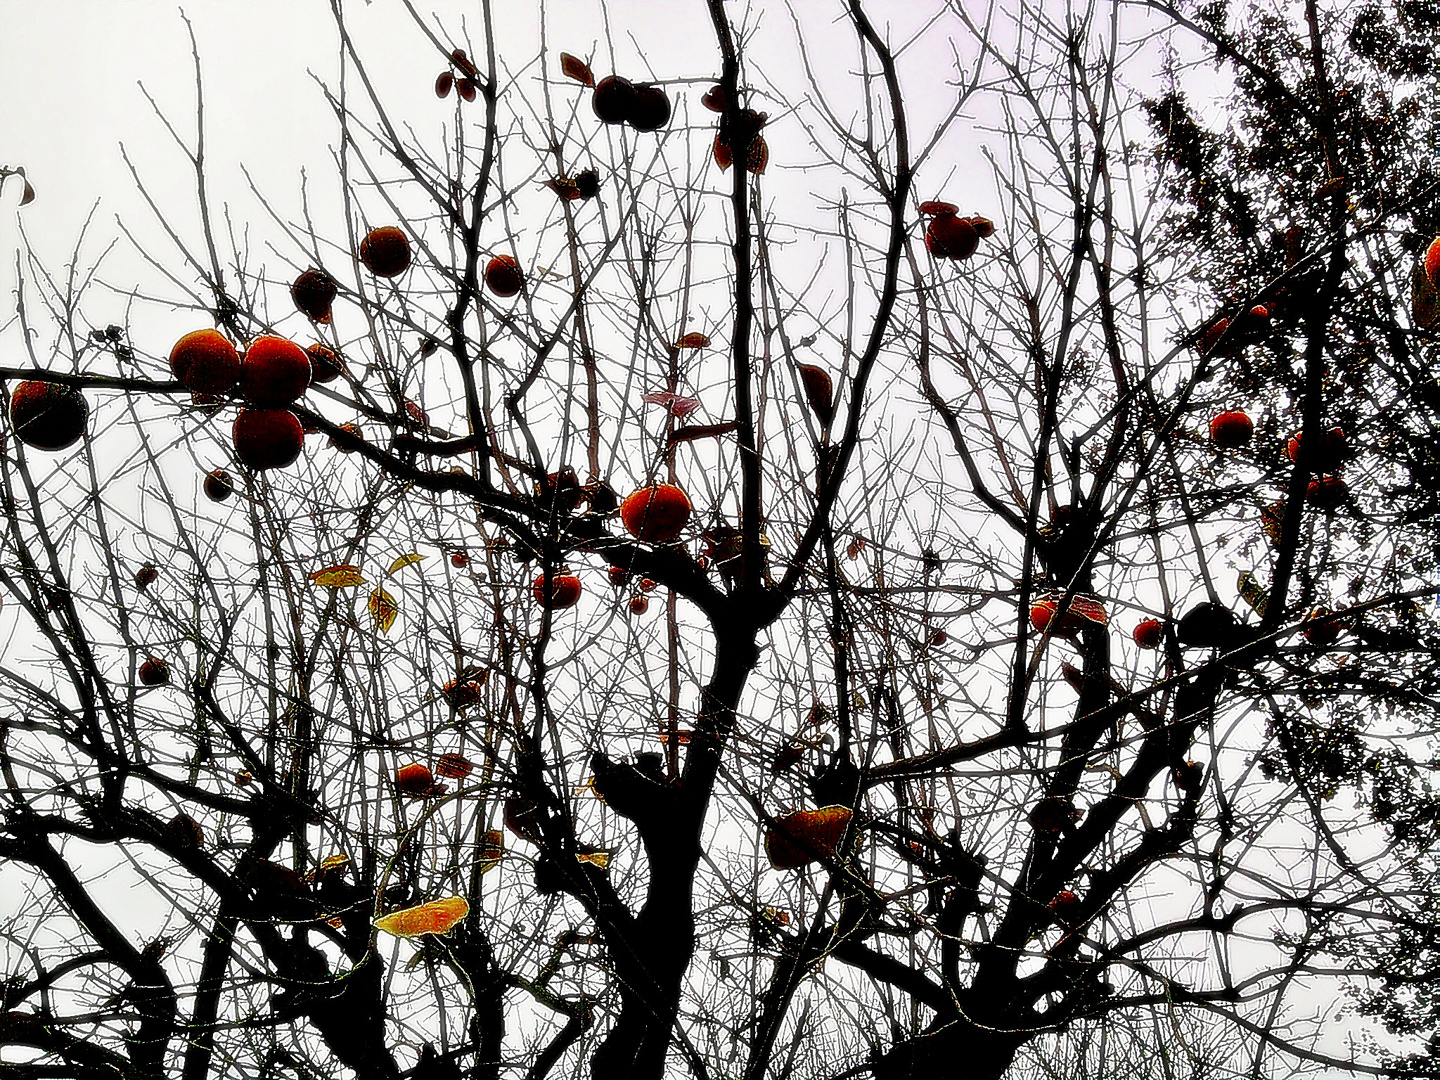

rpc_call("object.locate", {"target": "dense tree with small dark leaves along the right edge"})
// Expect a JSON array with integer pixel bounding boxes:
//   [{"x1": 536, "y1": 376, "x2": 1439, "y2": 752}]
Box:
[{"x1": 1146, "y1": 0, "x2": 1440, "y2": 1068}]
